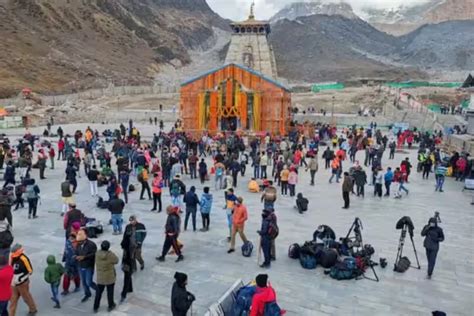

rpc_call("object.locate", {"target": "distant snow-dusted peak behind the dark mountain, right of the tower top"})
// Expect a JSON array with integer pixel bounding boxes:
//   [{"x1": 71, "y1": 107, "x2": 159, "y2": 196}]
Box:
[{"x1": 270, "y1": 1, "x2": 357, "y2": 23}]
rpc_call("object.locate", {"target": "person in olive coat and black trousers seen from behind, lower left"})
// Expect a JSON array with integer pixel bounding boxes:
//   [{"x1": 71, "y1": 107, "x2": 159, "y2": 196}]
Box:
[{"x1": 94, "y1": 240, "x2": 119, "y2": 313}]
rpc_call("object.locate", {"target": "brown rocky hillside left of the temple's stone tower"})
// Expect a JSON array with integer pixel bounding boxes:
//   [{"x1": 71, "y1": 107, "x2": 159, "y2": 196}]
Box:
[{"x1": 0, "y1": 0, "x2": 228, "y2": 97}]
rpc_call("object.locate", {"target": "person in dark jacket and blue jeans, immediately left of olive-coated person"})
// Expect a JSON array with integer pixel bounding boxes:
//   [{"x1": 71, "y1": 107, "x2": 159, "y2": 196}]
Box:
[{"x1": 75, "y1": 229, "x2": 97, "y2": 302}]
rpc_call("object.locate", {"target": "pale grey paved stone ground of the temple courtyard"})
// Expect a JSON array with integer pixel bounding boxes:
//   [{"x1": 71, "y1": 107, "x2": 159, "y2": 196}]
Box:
[{"x1": 4, "y1": 126, "x2": 474, "y2": 316}]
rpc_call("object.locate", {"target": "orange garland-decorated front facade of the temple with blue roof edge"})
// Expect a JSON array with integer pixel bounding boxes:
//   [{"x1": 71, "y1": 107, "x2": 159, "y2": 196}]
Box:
[{"x1": 180, "y1": 64, "x2": 291, "y2": 135}]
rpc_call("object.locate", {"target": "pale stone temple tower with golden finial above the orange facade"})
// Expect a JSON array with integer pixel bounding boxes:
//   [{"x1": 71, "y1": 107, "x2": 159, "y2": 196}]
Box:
[{"x1": 225, "y1": 4, "x2": 277, "y2": 79}]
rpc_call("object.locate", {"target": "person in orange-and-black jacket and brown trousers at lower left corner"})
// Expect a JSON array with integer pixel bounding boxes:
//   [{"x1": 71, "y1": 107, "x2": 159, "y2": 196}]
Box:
[{"x1": 9, "y1": 244, "x2": 38, "y2": 316}]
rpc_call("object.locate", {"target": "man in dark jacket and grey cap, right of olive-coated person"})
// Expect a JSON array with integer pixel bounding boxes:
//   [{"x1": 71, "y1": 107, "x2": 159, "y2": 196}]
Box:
[{"x1": 123, "y1": 215, "x2": 147, "y2": 271}]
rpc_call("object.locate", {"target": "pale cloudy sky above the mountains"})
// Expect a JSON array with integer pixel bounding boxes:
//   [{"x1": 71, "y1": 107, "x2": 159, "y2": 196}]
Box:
[{"x1": 207, "y1": 0, "x2": 429, "y2": 21}]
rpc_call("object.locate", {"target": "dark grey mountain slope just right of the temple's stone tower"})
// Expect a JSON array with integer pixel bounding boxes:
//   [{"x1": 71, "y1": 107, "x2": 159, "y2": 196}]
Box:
[{"x1": 270, "y1": 15, "x2": 424, "y2": 82}]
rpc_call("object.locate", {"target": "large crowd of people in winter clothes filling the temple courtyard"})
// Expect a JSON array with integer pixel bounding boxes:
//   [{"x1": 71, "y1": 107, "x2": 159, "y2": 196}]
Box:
[{"x1": 0, "y1": 119, "x2": 473, "y2": 316}]
